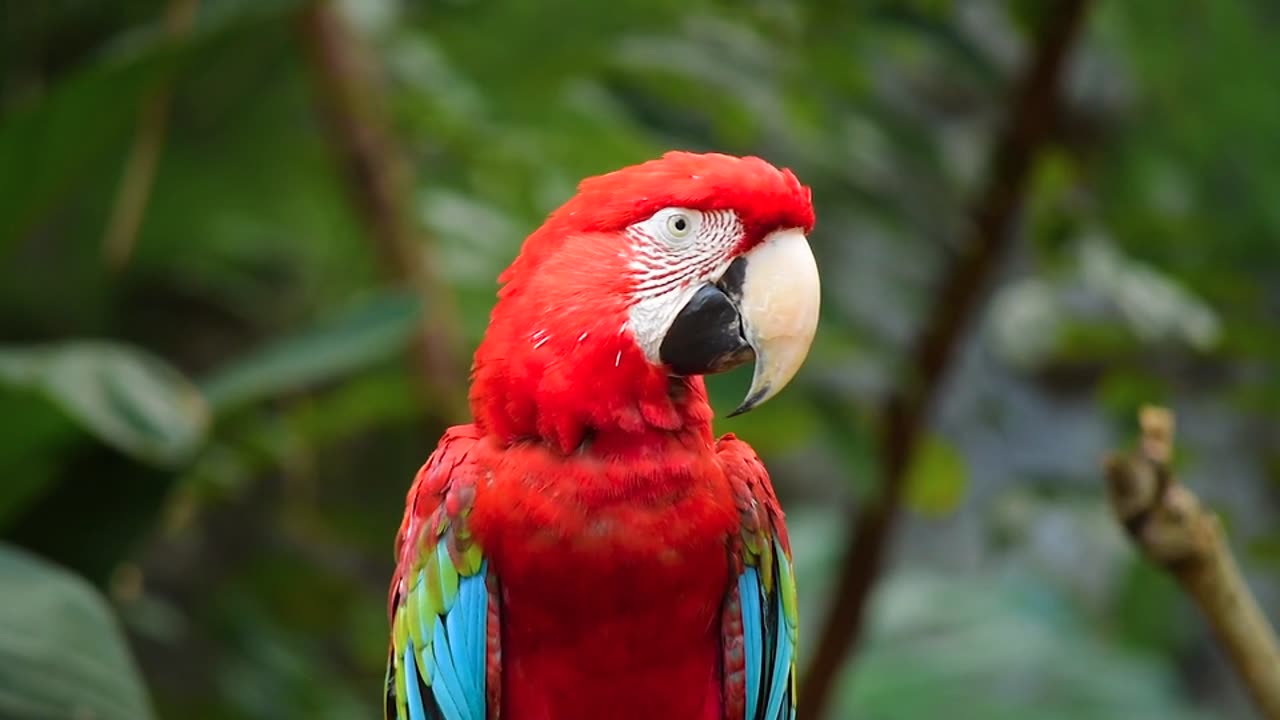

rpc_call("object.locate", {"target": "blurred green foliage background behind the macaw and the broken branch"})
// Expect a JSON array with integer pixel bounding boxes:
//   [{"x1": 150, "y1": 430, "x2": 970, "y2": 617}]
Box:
[{"x1": 0, "y1": 0, "x2": 1280, "y2": 720}]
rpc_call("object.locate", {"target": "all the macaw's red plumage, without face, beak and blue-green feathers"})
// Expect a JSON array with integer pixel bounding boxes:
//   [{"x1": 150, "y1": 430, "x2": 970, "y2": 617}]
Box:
[{"x1": 392, "y1": 148, "x2": 813, "y2": 720}]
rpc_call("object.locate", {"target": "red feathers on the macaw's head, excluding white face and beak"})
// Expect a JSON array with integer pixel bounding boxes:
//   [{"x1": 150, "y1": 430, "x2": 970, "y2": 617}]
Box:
[{"x1": 471, "y1": 152, "x2": 814, "y2": 452}]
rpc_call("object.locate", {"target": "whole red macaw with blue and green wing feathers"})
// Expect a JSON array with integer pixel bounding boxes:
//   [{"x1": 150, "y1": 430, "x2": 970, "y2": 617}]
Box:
[{"x1": 384, "y1": 151, "x2": 820, "y2": 720}]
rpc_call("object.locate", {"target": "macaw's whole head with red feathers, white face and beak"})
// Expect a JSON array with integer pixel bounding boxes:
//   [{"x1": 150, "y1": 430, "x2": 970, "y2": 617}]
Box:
[{"x1": 471, "y1": 152, "x2": 819, "y2": 452}]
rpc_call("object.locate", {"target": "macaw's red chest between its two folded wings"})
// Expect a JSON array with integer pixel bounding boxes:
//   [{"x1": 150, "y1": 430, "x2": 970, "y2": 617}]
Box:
[{"x1": 471, "y1": 437, "x2": 739, "y2": 720}]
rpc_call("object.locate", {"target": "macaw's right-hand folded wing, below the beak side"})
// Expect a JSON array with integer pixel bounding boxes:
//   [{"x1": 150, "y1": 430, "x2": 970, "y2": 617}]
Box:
[{"x1": 716, "y1": 434, "x2": 799, "y2": 720}]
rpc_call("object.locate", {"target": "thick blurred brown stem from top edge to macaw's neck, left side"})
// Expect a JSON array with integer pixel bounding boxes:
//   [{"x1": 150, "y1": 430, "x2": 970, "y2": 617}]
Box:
[{"x1": 301, "y1": 0, "x2": 467, "y2": 420}]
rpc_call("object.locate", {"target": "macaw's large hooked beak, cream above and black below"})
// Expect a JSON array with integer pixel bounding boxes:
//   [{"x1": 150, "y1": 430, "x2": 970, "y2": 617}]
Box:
[{"x1": 659, "y1": 228, "x2": 820, "y2": 418}]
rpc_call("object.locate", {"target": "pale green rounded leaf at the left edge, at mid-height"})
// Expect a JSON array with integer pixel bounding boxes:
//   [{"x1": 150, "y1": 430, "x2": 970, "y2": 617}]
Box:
[{"x1": 0, "y1": 341, "x2": 209, "y2": 465}]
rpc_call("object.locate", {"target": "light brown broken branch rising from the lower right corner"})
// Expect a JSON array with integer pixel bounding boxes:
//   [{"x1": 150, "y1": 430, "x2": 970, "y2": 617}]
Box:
[{"x1": 1106, "y1": 407, "x2": 1280, "y2": 719}]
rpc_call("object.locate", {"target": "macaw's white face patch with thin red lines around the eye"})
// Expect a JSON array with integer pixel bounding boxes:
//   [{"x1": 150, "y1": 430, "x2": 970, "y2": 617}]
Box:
[{"x1": 626, "y1": 208, "x2": 744, "y2": 364}]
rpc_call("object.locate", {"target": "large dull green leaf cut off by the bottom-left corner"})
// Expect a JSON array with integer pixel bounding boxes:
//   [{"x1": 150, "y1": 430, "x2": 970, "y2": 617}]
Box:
[{"x1": 0, "y1": 543, "x2": 152, "y2": 720}]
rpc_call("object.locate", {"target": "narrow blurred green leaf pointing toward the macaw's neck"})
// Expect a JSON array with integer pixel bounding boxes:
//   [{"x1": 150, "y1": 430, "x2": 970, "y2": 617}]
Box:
[{"x1": 202, "y1": 285, "x2": 422, "y2": 413}]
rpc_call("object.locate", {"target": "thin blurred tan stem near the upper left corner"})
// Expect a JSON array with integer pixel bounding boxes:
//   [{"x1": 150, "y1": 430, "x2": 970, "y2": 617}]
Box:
[{"x1": 102, "y1": 0, "x2": 200, "y2": 270}]
